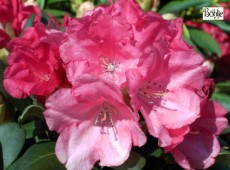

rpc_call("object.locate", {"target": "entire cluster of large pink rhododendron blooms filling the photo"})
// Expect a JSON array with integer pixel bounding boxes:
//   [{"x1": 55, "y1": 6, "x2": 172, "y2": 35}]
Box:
[{"x1": 1, "y1": 0, "x2": 228, "y2": 170}]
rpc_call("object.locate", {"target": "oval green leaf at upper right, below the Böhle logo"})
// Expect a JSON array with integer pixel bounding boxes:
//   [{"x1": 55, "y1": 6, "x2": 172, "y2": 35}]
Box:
[{"x1": 189, "y1": 29, "x2": 221, "y2": 55}]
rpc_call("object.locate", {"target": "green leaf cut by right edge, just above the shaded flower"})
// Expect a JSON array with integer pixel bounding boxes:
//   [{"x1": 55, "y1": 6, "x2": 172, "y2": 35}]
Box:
[{"x1": 212, "y1": 92, "x2": 230, "y2": 111}]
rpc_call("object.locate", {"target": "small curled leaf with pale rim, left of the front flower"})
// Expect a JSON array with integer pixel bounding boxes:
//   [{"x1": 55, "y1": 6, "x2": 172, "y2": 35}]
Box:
[{"x1": 18, "y1": 105, "x2": 44, "y2": 124}]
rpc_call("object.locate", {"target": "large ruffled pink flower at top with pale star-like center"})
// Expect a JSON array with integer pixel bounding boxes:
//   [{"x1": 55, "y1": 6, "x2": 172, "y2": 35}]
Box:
[{"x1": 60, "y1": 0, "x2": 182, "y2": 87}]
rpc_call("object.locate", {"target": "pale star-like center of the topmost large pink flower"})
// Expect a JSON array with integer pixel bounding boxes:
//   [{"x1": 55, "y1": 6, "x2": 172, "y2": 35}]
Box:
[{"x1": 99, "y1": 56, "x2": 119, "y2": 73}]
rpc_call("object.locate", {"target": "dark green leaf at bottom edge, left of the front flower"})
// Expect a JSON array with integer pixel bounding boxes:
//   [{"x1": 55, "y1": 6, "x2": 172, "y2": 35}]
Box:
[{"x1": 7, "y1": 142, "x2": 66, "y2": 170}]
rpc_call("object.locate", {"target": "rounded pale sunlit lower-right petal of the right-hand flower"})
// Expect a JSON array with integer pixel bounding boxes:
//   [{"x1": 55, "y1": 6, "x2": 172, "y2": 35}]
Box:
[{"x1": 156, "y1": 88, "x2": 200, "y2": 129}]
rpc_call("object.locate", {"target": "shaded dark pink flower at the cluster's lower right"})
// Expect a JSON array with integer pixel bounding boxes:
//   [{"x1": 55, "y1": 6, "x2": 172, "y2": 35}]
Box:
[{"x1": 171, "y1": 100, "x2": 228, "y2": 169}]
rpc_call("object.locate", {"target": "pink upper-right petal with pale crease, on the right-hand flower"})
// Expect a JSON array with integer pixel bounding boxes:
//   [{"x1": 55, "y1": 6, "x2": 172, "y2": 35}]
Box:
[{"x1": 166, "y1": 50, "x2": 206, "y2": 89}]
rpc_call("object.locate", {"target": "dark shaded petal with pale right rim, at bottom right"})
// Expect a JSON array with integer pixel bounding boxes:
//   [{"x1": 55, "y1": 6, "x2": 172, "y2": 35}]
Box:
[{"x1": 172, "y1": 131, "x2": 220, "y2": 169}]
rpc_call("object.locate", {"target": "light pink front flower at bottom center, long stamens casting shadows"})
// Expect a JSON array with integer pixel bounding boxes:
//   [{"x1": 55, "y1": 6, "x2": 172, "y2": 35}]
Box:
[{"x1": 44, "y1": 75, "x2": 146, "y2": 170}]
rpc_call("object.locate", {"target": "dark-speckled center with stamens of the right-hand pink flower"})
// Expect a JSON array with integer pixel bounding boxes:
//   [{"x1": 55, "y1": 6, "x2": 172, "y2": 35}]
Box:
[{"x1": 138, "y1": 81, "x2": 168, "y2": 104}]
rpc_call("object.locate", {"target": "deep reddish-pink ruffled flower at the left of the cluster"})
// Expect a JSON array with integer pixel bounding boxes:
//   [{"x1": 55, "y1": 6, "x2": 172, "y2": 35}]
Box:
[{"x1": 3, "y1": 25, "x2": 65, "y2": 98}]
